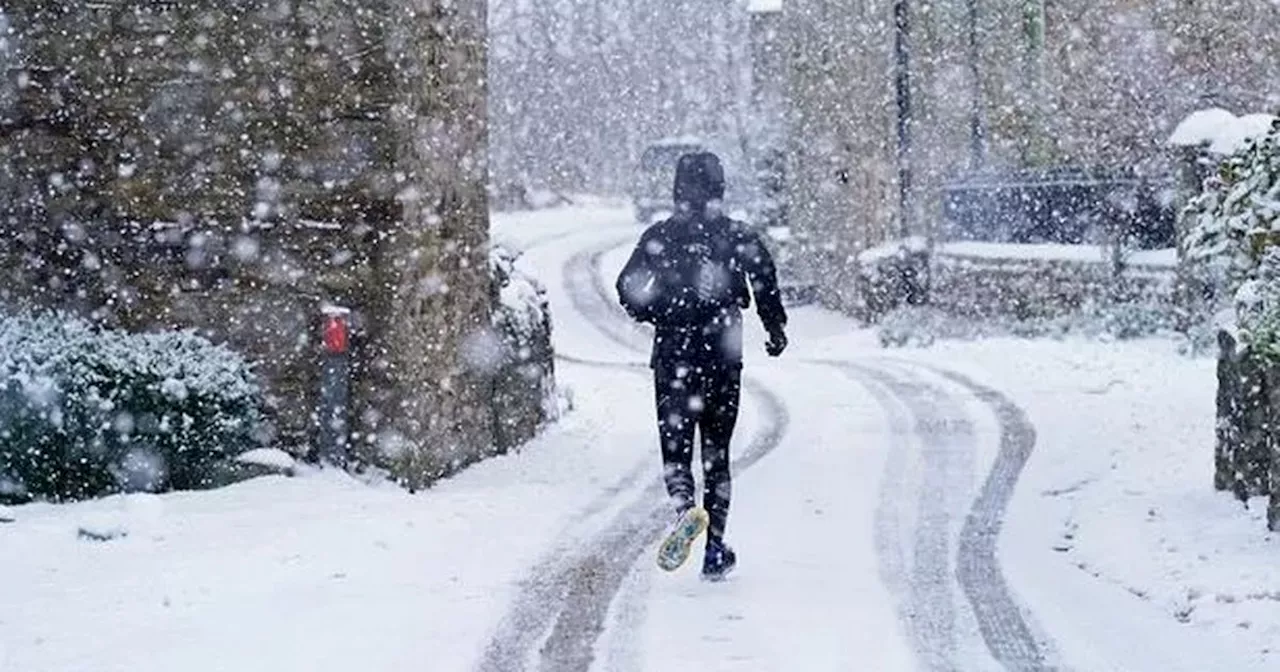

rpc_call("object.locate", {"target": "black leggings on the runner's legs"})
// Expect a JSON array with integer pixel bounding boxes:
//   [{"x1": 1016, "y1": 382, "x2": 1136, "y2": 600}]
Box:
[{"x1": 654, "y1": 364, "x2": 742, "y2": 540}]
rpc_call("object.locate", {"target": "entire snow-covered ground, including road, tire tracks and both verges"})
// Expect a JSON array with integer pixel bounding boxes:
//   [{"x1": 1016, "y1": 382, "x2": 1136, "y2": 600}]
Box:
[{"x1": 0, "y1": 207, "x2": 1280, "y2": 672}]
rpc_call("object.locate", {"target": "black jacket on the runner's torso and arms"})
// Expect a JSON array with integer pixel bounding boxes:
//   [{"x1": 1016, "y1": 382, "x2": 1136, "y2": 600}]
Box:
[{"x1": 616, "y1": 212, "x2": 787, "y2": 367}]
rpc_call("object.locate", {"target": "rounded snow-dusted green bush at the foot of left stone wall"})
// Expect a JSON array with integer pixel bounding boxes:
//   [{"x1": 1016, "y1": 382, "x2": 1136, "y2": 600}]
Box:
[{"x1": 0, "y1": 314, "x2": 261, "y2": 502}]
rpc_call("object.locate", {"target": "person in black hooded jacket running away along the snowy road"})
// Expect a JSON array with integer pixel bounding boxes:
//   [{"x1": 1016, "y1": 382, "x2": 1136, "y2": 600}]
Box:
[{"x1": 617, "y1": 152, "x2": 787, "y2": 580}]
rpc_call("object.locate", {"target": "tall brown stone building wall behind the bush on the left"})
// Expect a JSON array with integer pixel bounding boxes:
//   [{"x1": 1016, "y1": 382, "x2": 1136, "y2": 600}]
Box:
[{"x1": 0, "y1": 0, "x2": 550, "y2": 486}]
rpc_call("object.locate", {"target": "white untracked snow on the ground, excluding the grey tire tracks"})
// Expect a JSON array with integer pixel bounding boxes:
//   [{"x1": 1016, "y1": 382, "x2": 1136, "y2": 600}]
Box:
[{"x1": 0, "y1": 202, "x2": 1280, "y2": 672}]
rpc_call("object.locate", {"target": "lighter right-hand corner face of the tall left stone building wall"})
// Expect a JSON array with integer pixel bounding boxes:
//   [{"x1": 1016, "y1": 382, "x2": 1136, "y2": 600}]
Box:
[{"x1": 364, "y1": 0, "x2": 500, "y2": 488}]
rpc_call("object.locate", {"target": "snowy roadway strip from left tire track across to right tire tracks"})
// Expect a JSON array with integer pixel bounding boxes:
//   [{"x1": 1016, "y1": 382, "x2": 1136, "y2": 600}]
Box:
[{"x1": 483, "y1": 212, "x2": 1042, "y2": 671}]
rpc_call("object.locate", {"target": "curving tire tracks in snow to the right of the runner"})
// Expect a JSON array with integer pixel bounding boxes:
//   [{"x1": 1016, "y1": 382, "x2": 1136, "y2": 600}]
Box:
[{"x1": 827, "y1": 361, "x2": 1048, "y2": 672}]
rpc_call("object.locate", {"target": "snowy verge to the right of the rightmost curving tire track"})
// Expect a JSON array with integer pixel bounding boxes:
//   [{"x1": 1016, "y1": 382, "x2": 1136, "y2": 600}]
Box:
[{"x1": 885, "y1": 338, "x2": 1280, "y2": 672}]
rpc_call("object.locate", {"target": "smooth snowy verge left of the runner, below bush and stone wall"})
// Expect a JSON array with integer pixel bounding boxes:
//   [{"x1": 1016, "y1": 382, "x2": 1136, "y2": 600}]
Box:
[{"x1": 0, "y1": 350, "x2": 675, "y2": 672}]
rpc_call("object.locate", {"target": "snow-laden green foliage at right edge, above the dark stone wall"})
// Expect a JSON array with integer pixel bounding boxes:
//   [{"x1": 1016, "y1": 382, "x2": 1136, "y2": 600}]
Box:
[{"x1": 1183, "y1": 116, "x2": 1280, "y2": 340}]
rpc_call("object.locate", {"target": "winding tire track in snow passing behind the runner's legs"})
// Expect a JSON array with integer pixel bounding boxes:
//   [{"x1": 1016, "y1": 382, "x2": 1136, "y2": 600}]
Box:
[{"x1": 480, "y1": 230, "x2": 788, "y2": 672}]
